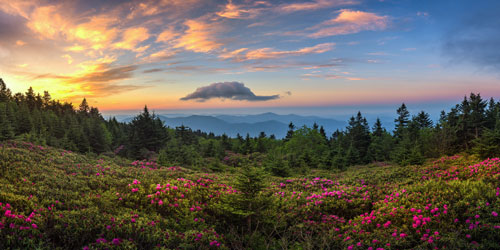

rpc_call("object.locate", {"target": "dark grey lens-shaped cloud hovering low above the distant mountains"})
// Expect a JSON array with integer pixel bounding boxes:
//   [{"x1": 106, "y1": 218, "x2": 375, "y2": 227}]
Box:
[{"x1": 180, "y1": 82, "x2": 280, "y2": 102}]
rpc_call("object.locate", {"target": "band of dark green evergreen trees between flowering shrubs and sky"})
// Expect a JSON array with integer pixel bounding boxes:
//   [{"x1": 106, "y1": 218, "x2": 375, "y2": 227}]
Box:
[{"x1": 0, "y1": 79, "x2": 500, "y2": 176}]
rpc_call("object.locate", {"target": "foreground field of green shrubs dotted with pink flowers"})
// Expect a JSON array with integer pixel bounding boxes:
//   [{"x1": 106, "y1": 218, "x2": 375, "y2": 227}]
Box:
[{"x1": 0, "y1": 141, "x2": 500, "y2": 249}]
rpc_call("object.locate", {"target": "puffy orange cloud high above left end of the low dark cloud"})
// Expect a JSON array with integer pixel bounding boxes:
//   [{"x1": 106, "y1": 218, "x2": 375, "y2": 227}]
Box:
[{"x1": 174, "y1": 20, "x2": 222, "y2": 53}]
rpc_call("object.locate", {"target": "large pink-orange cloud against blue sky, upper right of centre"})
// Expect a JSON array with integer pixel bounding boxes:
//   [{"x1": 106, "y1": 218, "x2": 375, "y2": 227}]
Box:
[{"x1": 308, "y1": 9, "x2": 390, "y2": 38}]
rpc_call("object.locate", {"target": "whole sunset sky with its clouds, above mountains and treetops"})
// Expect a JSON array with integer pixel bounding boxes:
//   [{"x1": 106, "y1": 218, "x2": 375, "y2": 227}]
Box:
[{"x1": 0, "y1": 0, "x2": 500, "y2": 117}]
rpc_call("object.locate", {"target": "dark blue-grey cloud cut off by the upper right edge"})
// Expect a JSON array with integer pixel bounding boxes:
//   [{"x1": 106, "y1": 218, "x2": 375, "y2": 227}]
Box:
[{"x1": 442, "y1": 4, "x2": 500, "y2": 71}]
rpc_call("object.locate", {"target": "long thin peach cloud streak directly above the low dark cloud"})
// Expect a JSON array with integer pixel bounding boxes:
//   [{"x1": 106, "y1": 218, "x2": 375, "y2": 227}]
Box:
[{"x1": 219, "y1": 43, "x2": 335, "y2": 62}]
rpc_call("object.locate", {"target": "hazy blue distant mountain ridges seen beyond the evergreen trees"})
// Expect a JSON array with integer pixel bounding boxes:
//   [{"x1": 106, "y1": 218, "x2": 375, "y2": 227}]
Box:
[{"x1": 117, "y1": 112, "x2": 347, "y2": 138}]
